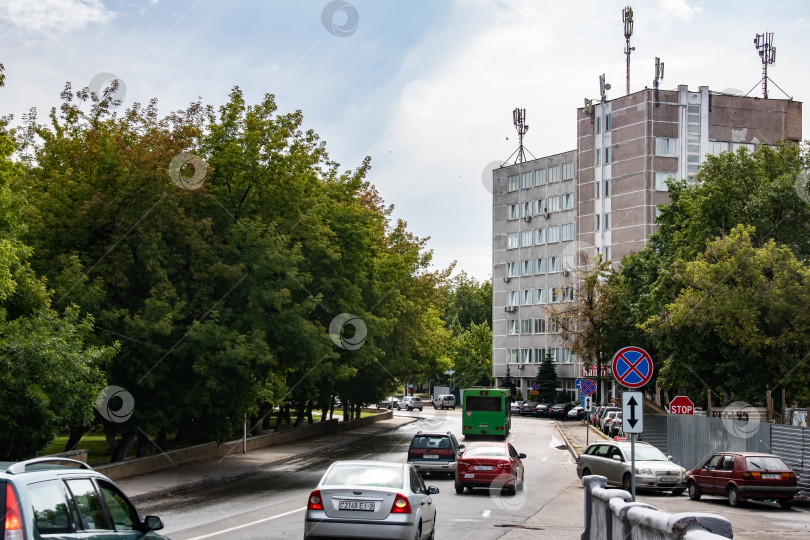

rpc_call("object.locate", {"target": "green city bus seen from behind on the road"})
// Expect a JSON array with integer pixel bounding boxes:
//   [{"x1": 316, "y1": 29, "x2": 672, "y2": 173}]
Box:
[{"x1": 461, "y1": 388, "x2": 512, "y2": 439}]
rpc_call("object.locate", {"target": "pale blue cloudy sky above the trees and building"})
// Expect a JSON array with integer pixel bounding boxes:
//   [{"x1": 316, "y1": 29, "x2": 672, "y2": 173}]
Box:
[{"x1": 0, "y1": 0, "x2": 810, "y2": 280}]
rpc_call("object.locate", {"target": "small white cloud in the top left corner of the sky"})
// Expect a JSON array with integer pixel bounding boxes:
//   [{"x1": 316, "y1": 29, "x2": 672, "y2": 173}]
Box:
[{"x1": 8, "y1": 0, "x2": 115, "y2": 34}]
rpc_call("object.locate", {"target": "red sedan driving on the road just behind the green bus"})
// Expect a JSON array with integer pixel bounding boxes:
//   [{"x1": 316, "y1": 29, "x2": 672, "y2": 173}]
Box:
[{"x1": 456, "y1": 442, "x2": 526, "y2": 495}]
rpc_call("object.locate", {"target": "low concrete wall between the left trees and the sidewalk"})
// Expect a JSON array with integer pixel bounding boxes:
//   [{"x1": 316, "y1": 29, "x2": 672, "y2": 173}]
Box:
[{"x1": 93, "y1": 410, "x2": 394, "y2": 480}]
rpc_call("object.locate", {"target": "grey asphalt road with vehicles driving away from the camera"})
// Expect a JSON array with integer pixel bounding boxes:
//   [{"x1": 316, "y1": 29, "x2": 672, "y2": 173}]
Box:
[{"x1": 138, "y1": 409, "x2": 579, "y2": 540}]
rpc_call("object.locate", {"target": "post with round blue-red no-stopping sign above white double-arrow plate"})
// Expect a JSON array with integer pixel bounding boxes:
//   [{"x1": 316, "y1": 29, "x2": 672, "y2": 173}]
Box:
[{"x1": 611, "y1": 346, "x2": 653, "y2": 502}]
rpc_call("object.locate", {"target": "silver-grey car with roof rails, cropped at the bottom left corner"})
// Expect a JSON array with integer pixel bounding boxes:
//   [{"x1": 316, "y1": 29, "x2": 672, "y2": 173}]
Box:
[{"x1": 0, "y1": 457, "x2": 168, "y2": 540}]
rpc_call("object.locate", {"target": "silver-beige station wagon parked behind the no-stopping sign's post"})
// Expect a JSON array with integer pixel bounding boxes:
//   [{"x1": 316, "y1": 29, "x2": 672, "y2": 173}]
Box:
[{"x1": 577, "y1": 441, "x2": 686, "y2": 495}]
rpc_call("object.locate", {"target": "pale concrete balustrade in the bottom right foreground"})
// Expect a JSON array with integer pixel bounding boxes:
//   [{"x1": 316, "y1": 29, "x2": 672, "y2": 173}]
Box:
[{"x1": 581, "y1": 475, "x2": 733, "y2": 540}]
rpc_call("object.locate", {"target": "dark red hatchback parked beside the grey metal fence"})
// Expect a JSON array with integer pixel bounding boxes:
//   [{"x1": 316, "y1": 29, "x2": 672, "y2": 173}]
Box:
[{"x1": 686, "y1": 452, "x2": 799, "y2": 508}]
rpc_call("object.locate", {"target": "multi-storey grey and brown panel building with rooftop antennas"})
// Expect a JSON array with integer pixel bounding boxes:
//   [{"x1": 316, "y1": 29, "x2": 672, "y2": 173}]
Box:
[{"x1": 492, "y1": 85, "x2": 801, "y2": 397}]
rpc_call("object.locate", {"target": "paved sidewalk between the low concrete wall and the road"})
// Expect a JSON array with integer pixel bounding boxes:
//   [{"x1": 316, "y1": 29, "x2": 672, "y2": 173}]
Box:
[{"x1": 116, "y1": 417, "x2": 417, "y2": 502}]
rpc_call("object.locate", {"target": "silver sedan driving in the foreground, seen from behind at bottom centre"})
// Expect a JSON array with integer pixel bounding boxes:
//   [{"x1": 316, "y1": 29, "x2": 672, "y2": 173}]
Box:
[{"x1": 304, "y1": 461, "x2": 439, "y2": 540}]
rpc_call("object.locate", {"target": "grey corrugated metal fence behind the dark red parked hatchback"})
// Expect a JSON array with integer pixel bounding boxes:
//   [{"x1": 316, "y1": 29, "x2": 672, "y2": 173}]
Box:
[{"x1": 667, "y1": 414, "x2": 810, "y2": 497}]
